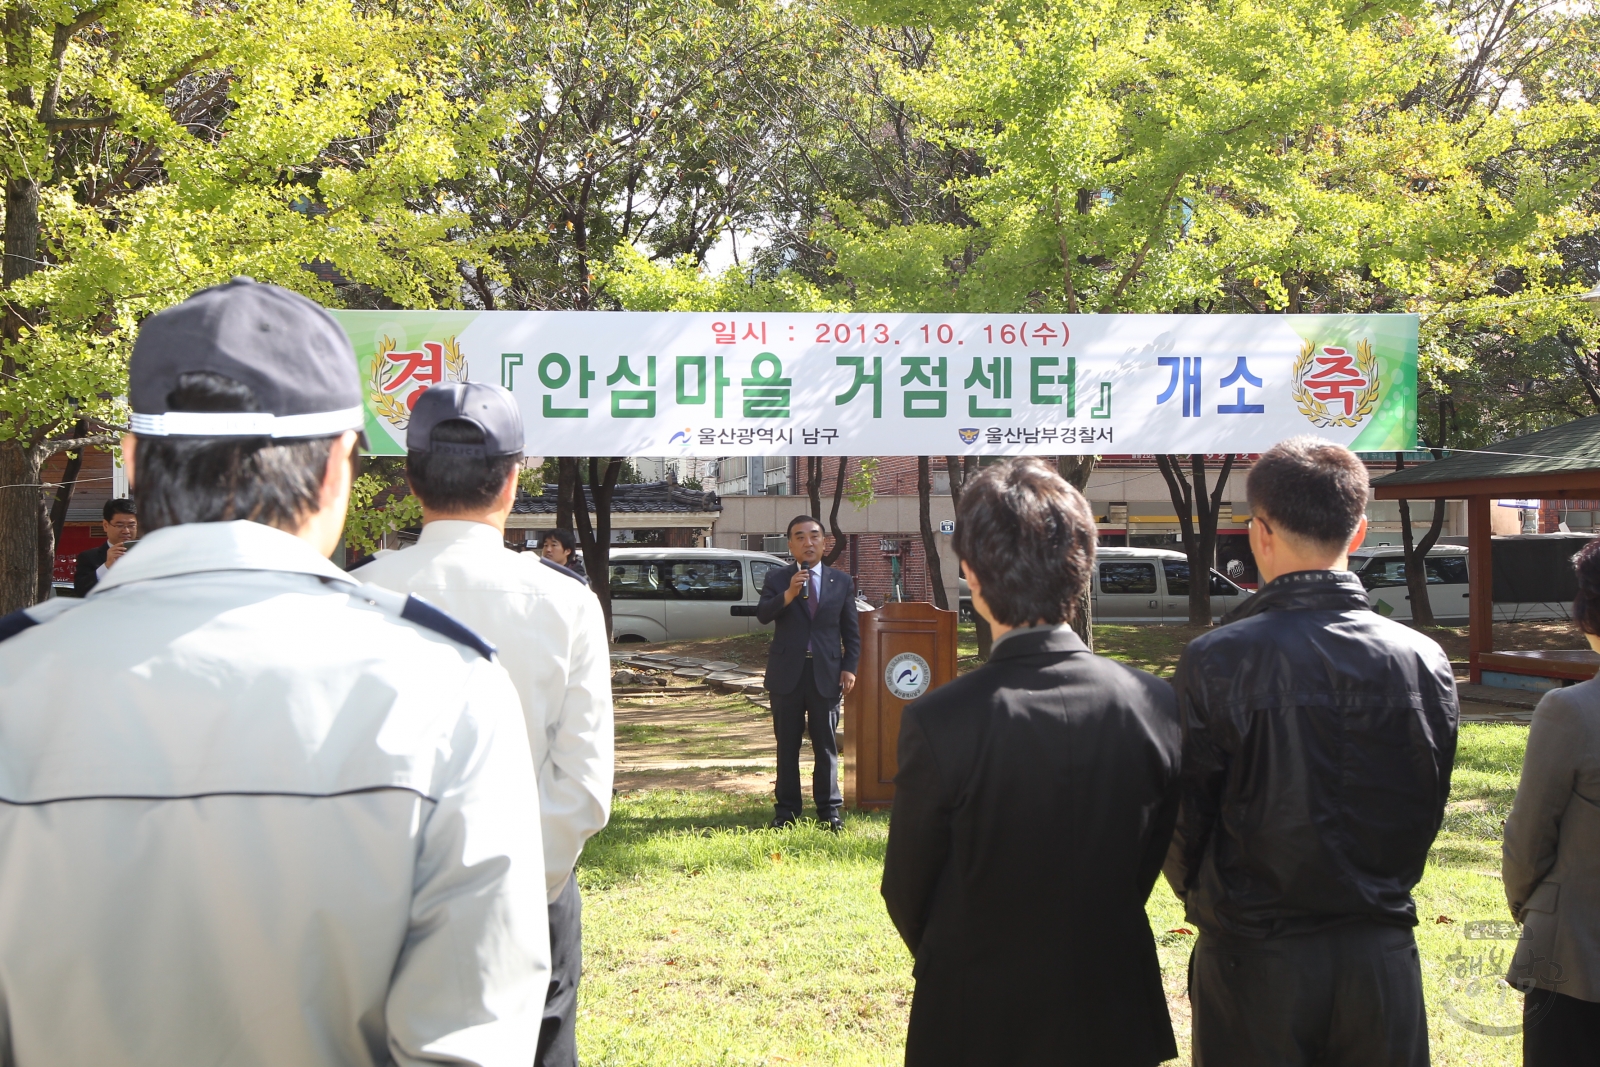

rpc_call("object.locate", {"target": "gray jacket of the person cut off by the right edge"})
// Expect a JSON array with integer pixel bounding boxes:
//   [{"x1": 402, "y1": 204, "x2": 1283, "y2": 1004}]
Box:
[{"x1": 1501, "y1": 680, "x2": 1600, "y2": 1001}]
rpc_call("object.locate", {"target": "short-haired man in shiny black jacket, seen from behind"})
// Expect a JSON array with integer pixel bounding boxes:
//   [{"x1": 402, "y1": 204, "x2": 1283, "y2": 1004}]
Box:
[{"x1": 1165, "y1": 437, "x2": 1459, "y2": 1067}]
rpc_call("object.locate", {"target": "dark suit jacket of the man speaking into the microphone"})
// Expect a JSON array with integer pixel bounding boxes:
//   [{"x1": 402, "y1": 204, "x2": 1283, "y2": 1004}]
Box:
[{"x1": 755, "y1": 563, "x2": 861, "y2": 696}]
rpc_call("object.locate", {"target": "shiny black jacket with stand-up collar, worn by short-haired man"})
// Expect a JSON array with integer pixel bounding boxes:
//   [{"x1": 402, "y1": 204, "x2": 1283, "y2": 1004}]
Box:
[{"x1": 1165, "y1": 571, "x2": 1459, "y2": 937}]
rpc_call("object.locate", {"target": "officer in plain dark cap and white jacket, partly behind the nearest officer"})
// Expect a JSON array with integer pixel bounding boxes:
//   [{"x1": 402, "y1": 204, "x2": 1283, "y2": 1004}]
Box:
[{"x1": 357, "y1": 382, "x2": 613, "y2": 1067}]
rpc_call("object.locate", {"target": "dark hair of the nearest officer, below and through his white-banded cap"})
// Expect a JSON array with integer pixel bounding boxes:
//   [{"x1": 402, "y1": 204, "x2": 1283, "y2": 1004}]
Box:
[{"x1": 132, "y1": 371, "x2": 342, "y2": 533}]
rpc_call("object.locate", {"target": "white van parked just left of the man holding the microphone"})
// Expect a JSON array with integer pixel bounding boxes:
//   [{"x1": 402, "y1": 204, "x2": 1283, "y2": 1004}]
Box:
[{"x1": 601, "y1": 549, "x2": 786, "y2": 645}]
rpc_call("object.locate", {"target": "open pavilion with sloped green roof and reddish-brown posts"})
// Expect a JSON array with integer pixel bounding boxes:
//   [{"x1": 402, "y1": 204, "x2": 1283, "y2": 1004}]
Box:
[{"x1": 1373, "y1": 414, "x2": 1600, "y2": 683}]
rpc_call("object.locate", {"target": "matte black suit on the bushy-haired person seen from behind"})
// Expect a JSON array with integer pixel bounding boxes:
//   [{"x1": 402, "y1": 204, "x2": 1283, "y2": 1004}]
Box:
[{"x1": 883, "y1": 630, "x2": 1182, "y2": 1067}]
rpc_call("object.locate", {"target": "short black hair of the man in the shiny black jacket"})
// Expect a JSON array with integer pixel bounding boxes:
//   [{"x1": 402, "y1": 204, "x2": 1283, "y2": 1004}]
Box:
[{"x1": 1245, "y1": 435, "x2": 1366, "y2": 549}]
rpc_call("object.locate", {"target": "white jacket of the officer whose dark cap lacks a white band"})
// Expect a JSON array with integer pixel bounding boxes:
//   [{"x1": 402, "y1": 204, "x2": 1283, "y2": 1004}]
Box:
[{"x1": 354, "y1": 520, "x2": 613, "y2": 901}]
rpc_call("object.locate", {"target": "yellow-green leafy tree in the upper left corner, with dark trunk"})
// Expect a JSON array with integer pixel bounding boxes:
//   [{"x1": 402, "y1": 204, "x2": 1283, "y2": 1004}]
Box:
[{"x1": 0, "y1": 0, "x2": 502, "y2": 613}]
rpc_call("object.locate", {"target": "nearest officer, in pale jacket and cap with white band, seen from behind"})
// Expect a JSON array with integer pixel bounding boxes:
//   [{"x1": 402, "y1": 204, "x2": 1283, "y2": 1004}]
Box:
[{"x1": 0, "y1": 278, "x2": 549, "y2": 1067}]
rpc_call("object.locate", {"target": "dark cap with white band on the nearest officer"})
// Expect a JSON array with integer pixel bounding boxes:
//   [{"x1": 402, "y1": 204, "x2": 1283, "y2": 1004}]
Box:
[{"x1": 128, "y1": 278, "x2": 365, "y2": 438}]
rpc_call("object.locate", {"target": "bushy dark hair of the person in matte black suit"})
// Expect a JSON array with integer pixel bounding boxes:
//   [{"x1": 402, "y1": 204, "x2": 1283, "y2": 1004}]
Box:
[{"x1": 952, "y1": 458, "x2": 1096, "y2": 625}]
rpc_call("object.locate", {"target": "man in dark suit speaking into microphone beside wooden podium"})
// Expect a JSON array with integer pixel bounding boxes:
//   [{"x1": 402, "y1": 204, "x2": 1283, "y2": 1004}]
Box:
[{"x1": 755, "y1": 515, "x2": 861, "y2": 830}]
